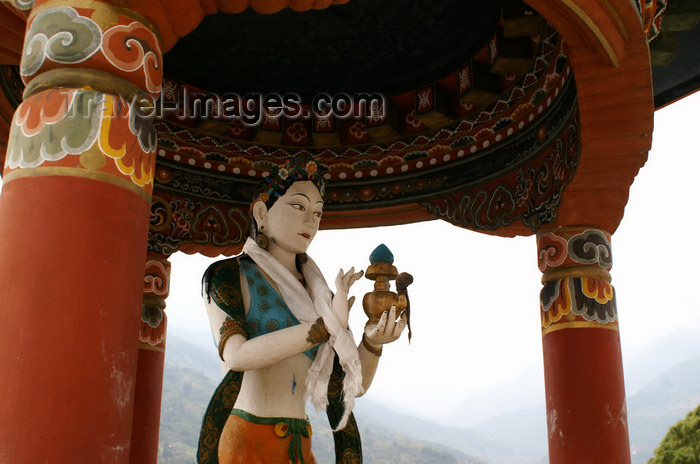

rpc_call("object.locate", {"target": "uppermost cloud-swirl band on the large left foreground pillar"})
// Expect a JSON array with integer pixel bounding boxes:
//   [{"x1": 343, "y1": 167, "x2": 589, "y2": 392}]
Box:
[{"x1": 20, "y1": 0, "x2": 163, "y2": 98}]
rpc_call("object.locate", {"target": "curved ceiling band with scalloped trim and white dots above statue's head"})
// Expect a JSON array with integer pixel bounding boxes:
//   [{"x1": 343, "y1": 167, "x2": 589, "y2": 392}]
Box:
[{"x1": 156, "y1": 24, "x2": 571, "y2": 181}]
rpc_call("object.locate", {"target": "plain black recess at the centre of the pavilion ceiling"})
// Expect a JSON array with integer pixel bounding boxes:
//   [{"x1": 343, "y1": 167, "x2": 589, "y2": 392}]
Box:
[{"x1": 164, "y1": 0, "x2": 501, "y2": 95}]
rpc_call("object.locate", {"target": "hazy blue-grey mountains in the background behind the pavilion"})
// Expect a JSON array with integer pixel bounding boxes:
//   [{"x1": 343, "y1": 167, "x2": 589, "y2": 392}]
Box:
[{"x1": 159, "y1": 331, "x2": 700, "y2": 464}]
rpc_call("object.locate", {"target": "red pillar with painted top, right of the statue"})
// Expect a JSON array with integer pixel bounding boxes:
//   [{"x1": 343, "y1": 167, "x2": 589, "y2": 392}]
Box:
[{"x1": 537, "y1": 228, "x2": 630, "y2": 464}]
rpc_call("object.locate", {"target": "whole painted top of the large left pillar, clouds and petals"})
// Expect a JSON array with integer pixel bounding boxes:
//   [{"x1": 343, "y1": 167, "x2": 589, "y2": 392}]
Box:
[{"x1": 3, "y1": 0, "x2": 163, "y2": 199}]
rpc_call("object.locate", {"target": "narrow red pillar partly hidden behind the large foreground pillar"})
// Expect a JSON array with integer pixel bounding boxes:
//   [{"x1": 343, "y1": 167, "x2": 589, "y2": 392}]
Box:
[{"x1": 129, "y1": 254, "x2": 170, "y2": 464}]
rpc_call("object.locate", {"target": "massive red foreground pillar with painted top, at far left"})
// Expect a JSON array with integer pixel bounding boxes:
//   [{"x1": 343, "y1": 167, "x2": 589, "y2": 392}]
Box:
[{"x1": 0, "y1": 0, "x2": 162, "y2": 464}]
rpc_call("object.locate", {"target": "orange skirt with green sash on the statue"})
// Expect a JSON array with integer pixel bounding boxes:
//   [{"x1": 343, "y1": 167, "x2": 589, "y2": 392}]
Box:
[{"x1": 219, "y1": 409, "x2": 316, "y2": 464}]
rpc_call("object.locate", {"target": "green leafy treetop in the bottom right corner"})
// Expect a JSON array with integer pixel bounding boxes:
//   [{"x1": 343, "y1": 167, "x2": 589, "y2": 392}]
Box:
[{"x1": 649, "y1": 406, "x2": 700, "y2": 464}]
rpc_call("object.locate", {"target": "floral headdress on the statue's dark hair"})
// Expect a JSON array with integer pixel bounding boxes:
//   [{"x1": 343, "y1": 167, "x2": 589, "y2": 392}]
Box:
[{"x1": 260, "y1": 156, "x2": 328, "y2": 202}]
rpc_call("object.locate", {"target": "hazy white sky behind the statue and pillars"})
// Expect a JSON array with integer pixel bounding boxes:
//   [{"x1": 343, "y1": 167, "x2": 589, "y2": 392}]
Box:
[{"x1": 0, "y1": 89, "x2": 700, "y2": 424}]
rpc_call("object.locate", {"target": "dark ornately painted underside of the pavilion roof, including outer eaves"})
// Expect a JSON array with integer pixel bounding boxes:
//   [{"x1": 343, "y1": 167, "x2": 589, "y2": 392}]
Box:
[{"x1": 0, "y1": 0, "x2": 700, "y2": 254}]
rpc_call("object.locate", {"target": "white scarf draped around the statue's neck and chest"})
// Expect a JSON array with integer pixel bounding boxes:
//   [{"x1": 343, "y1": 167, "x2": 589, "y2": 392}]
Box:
[{"x1": 243, "y1": 238, "x2": 364, "y2": 431}]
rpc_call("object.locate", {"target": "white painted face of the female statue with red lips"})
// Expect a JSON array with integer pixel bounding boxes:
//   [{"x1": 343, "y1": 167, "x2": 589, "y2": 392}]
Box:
[{"x1": 256, "y1": 181, "x2": 323, "y2": 254}]
